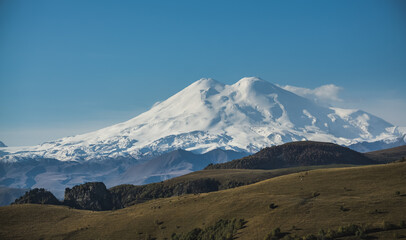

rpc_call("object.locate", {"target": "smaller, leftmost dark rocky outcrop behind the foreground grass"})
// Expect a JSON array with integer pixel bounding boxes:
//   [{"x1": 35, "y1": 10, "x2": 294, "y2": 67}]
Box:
[{"x1": 14, "y1": 188, "x2": 61, "y2": 205}]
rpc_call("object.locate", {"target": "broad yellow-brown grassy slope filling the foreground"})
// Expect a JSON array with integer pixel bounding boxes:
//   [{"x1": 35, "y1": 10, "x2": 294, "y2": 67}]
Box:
[{"x1": 0, "y1": 163, "x2": 406, "y2": 239}]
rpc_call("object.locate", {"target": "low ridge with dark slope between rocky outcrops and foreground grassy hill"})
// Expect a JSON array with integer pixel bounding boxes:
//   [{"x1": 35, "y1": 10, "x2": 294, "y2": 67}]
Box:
[{"x1": 109, "y1": 165, "x2": 349, "y2": 209}]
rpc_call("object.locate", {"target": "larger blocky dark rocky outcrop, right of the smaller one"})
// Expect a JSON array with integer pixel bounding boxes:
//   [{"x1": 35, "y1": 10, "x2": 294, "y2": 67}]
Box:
[{"x1": 63, "y1": 182, "x2": 113, "y2": 211}]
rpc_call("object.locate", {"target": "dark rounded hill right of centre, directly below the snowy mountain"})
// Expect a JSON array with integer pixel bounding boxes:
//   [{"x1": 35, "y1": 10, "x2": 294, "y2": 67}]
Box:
[{"x1": 206, "y1": 141, "x2": 376, "y2": 169}]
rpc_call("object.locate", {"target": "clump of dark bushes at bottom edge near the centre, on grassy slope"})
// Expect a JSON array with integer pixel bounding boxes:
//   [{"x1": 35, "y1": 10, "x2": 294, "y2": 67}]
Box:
[{"x1": 171, "y1": 218, "x2": 246, "y2": 240}]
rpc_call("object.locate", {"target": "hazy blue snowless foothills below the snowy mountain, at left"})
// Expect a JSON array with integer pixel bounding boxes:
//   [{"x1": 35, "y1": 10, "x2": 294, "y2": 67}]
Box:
[{"x1": 0, "y1": 149, "x2": 247, "y2": 199}]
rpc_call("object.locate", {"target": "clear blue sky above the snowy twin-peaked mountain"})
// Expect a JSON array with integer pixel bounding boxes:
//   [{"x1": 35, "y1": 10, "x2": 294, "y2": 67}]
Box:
[{"x1": 0, "y1": 0, "x2": 406, "y2": 146}]
